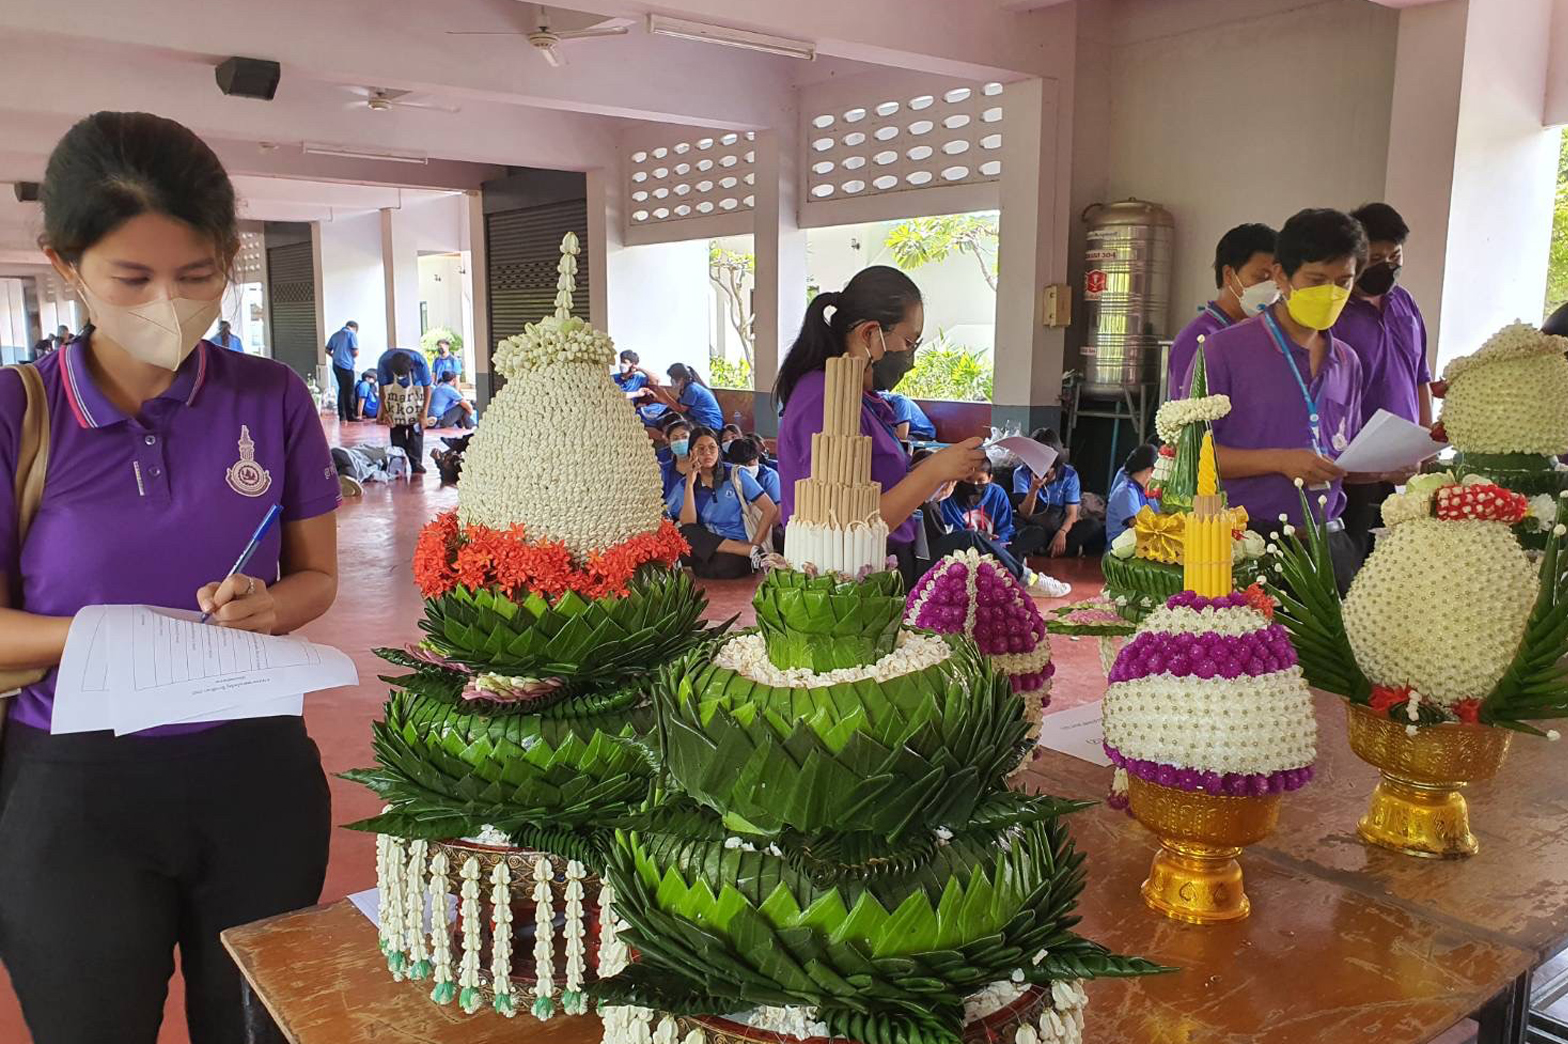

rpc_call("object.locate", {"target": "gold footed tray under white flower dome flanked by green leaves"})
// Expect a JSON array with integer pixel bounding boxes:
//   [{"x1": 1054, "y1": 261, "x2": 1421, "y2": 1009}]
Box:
[{"x1": 1345, "y1": 702, "x2": 1513, "y2": 859}]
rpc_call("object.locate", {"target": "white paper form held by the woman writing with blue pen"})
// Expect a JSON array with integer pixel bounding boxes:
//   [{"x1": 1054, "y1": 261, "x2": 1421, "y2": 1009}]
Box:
[{"x1": 53, "y1": 605, "x2": 359, "y2": 735}]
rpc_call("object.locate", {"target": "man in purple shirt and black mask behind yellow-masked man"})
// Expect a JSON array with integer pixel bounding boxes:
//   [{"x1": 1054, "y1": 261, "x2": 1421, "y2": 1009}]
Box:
[{"x1": 1334, "y1": 202, "x2": 1432, "y2": 556}]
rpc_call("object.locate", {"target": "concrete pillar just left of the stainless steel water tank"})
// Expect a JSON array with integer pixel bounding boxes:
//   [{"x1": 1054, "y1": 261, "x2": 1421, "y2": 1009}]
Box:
[{"x1": 991, "y1": 78, "x2": 1068, "y2": 431}]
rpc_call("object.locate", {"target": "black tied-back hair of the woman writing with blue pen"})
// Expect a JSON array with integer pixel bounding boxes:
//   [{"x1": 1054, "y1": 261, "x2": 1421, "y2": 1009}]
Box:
[{"x1": 39, "y1": 113, "x2": 240, "y2": 270}]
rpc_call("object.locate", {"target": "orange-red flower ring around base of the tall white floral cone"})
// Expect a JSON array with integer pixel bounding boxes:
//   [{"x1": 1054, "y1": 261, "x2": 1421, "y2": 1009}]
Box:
[{"x1": 414, "y1": 511, "x2": 690, "y2": 599}]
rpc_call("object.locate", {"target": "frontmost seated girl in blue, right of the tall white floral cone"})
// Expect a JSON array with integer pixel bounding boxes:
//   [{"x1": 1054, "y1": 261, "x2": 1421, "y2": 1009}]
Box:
[{"x1": 665, "y1": 428, "x2": 779, "y2": 580}]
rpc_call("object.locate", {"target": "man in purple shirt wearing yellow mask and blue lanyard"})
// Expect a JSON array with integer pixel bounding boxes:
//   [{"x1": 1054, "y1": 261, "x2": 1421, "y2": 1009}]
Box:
[{"x1": 1204, "y1": 210, "x2": 1367, "y2": 588}]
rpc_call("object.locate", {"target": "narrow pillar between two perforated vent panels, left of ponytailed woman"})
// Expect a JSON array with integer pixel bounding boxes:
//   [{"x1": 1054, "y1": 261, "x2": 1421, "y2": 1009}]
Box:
[{"x1": 751, "y1": 120, "x2": 806, "y2": 436}]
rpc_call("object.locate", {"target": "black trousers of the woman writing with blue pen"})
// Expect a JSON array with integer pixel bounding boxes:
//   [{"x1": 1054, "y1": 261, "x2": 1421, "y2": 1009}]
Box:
[{"x1": 0, "y1": 718, "x2": 331, "y2": 1044}]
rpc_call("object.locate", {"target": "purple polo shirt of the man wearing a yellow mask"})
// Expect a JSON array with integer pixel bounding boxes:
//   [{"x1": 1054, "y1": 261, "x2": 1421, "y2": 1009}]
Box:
[{"x1": 1203, "y1": 315, "x2": 1361, "y2": 536}]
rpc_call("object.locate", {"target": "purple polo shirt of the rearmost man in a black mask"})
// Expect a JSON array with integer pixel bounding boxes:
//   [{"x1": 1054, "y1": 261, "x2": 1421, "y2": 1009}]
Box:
[{"x1": 1334, "y1": 287, "x2": 1432, "y2": 423}]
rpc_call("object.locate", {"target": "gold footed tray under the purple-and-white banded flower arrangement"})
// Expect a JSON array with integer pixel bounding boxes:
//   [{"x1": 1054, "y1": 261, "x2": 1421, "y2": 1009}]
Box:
[{"x1": 1127, "y1": 776, "x2": 1279, "y2": 925}]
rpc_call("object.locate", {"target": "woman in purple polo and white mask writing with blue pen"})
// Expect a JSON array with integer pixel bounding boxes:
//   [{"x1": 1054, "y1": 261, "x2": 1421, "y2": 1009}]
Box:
[{"x1": 0, "y1": 113, "x2": 339, "y2": 1044}]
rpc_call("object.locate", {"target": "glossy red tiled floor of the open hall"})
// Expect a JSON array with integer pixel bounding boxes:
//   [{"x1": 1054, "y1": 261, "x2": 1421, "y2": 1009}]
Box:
[{"x1": 0, "y1": 419, "x2": 1105, "y2": 1044}]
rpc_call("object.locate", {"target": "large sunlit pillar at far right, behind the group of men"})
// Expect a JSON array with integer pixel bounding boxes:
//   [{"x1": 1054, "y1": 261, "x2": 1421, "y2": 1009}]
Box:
[{"x1": 1385, "y1": 0, "x2": 1563, "y2": 375}]
